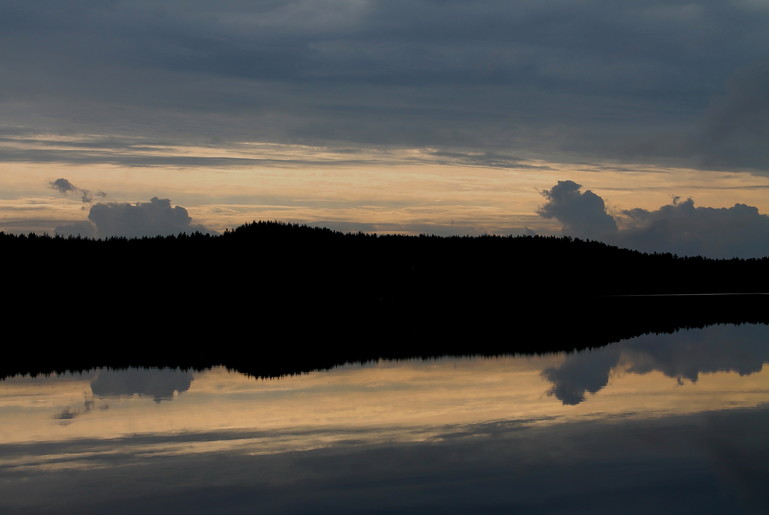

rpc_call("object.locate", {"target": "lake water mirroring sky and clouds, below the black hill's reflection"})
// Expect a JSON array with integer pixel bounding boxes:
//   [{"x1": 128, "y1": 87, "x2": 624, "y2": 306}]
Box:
[{"x1": 0, "y1": 325, "x2": 769, "y2": 514}]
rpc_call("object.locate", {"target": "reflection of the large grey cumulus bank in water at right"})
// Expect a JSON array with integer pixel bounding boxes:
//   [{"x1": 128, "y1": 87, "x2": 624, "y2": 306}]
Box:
[{"x1": 542, "y1": 325, "x2": 769, "y2": 405}]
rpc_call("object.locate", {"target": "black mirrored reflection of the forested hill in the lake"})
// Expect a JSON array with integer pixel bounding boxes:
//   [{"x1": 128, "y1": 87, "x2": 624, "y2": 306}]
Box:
[{"x1": 0, "y1": 296, "x2": 769, "y2": 378}]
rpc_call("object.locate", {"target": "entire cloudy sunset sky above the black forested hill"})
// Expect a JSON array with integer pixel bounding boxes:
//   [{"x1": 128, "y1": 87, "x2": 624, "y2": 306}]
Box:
[{"x1": 0, "y1": 0, "x2": 769, "y2": 257}]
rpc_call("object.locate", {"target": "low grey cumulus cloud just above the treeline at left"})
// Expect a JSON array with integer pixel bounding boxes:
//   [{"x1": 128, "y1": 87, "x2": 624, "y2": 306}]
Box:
[{"x1": 56, "y1": 197, "x2": 214, "y2": 238}]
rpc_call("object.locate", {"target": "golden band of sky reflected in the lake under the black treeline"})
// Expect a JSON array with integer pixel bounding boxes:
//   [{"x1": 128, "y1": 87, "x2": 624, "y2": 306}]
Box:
[{"x1": 0, "y1": 326, "x2": 769, "y2": 450}]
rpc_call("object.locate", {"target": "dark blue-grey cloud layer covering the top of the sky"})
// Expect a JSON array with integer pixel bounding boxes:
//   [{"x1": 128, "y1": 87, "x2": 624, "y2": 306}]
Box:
[{"x1": 0, "y1": 0, "x2": 769, "y2": 171}]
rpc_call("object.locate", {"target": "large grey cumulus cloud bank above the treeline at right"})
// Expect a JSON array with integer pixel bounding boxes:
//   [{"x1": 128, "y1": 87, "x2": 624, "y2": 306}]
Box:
[{"x1": 539, "y1": 181, "x2": 769, "y2": 258}]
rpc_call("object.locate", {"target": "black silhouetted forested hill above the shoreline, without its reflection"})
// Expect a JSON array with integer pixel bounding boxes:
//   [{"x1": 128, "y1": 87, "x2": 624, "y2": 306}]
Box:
[{"x1": 0, "y1": 222, "x2": 769, "y2": 302}]
